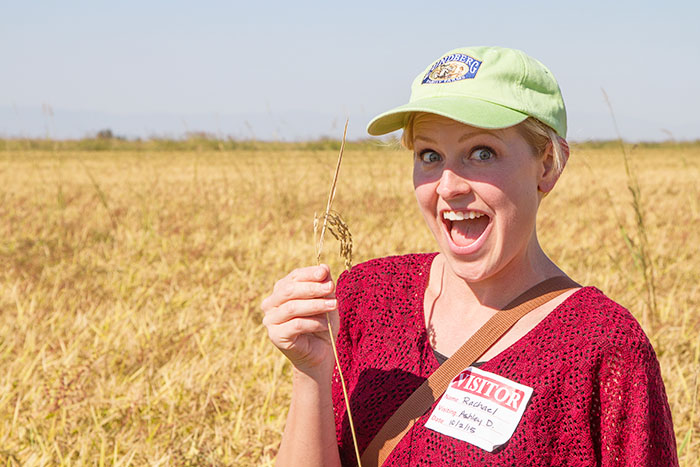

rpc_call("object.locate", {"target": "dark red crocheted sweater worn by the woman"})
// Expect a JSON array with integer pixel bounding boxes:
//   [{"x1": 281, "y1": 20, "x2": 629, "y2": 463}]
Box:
[{"x1": 333, "y1": 254, "x2": 678, "y2": 467}]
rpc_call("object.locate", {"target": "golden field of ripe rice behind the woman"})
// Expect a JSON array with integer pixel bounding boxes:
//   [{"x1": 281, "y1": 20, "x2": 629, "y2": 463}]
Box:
[{"x1": 0, "y1": 141, "x2": 700, "y2": 466}]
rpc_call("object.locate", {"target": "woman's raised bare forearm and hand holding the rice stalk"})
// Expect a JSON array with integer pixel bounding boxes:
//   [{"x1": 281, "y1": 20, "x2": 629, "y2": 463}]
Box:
[{"x1": 262, "y1": 265, "x2": 340, "y2": 466}]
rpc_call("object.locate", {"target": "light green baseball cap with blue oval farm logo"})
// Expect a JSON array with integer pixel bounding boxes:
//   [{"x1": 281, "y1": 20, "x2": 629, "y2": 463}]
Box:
[{"x1": 367, "y1": 47, "x2": 566, "y2": 138}]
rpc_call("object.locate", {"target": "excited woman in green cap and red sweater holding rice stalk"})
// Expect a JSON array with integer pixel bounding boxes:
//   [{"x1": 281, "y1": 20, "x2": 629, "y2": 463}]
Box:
[{"x1": 262, "y1": 47, "x2": 678, "y2": 466}]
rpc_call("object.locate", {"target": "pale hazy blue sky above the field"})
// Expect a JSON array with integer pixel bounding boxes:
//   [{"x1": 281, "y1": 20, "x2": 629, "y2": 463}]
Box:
[{"x1": 0, "y1": 0, "x2": 700, "y2": 141}]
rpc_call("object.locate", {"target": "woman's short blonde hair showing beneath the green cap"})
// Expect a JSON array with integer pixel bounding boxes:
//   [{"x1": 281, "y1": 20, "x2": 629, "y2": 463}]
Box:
[{"x1": 401, "y1": 112, "x2": 569, "y2": 174}]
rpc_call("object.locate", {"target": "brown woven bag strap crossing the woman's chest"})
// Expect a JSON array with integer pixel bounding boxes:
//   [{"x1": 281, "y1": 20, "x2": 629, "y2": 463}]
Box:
[{"x1": 362, "y1": 276, "x2": 580, "y2": 467}]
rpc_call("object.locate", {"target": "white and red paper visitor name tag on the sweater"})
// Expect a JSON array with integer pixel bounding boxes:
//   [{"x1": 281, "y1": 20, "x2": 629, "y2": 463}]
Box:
[{"x1": 425, "y1": 367, "x2": 532, "y2": 452}]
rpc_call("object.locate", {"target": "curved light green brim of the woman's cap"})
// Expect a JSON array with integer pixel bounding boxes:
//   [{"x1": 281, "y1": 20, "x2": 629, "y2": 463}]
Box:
[{"x1": 367, "y1": 96, "x2": 528, "y2": 136}]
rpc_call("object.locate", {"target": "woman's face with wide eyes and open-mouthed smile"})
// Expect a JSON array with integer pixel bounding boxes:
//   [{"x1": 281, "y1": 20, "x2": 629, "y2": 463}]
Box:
[{"x1": 413, "y1": 114, "x2": 547, "y2": 282}]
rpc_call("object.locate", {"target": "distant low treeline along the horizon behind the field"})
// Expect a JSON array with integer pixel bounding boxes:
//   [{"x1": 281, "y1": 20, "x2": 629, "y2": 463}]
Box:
[{"x1": 0, "y1": 135, "x2": 700, "y2": 151}]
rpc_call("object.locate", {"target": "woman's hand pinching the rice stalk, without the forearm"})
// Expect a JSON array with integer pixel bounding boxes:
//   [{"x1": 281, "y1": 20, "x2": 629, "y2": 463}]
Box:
[{"x1": 262, "y1": 264, "x2": 338, "y2": 376}]
